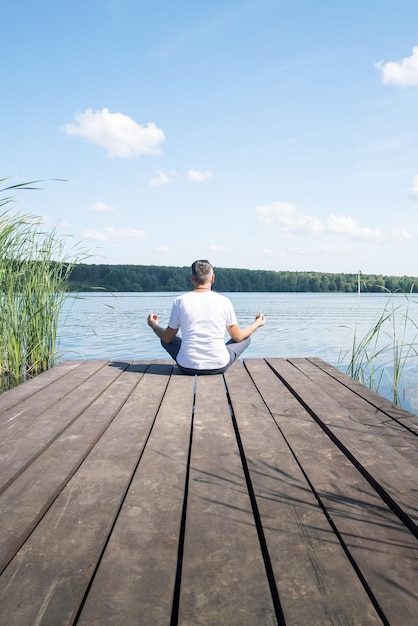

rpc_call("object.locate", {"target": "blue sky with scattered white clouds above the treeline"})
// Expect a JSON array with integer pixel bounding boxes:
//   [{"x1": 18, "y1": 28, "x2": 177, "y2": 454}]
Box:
[{"x1": 0, "y1": 0, "x2": 418, "y2": 275}]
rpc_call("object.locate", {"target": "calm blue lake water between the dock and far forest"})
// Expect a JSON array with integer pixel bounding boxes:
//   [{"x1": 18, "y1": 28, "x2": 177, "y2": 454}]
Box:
[{"x1": 58, "y1": 293, "x2": 418, "y2": 413}]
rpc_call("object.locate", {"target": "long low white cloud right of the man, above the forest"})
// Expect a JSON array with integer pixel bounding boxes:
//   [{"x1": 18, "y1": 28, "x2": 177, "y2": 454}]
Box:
[{"x1": 255, "y1": 202, "x2": 382, "y2": 239}]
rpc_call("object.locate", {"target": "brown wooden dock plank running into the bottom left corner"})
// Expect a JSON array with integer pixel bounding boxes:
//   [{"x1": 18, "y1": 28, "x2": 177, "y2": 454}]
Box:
[{"x1": 0, "y1": 365, "x2": 172, "y2": 626}]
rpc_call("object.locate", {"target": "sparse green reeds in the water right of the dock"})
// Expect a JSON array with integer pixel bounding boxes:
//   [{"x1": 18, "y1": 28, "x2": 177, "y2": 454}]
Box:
[{"x1": 343, "y1": 274, "x2": 418, "y2": 404}]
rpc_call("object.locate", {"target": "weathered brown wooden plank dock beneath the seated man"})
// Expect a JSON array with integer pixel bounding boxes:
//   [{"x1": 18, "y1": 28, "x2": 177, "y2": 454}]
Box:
[{"x1": 0, "y1": 358, "x2": 418, "y2": 626}]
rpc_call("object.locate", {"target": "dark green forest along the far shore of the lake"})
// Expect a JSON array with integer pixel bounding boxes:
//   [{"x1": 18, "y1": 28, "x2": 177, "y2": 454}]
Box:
[{"x1": 67, "y1": 263, "x2": 418, "y2": 293}]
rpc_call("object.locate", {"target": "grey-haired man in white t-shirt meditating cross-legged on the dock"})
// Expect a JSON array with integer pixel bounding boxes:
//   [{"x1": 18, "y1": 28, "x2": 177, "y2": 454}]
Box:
[{"x1": 148, "y1": 260, "x2": 265, "y2": 375}]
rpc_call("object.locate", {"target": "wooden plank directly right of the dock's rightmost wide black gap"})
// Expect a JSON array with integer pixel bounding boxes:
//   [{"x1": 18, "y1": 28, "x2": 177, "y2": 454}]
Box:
[{"x1": 268, "y1": 359, "x2": 418, "y2": 537}]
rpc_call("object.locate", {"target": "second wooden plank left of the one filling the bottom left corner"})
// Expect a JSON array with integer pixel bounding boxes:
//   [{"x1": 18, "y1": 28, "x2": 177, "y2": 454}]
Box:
[{"x1": 0, "y1": 362, "x2": 127, "y2": 493}]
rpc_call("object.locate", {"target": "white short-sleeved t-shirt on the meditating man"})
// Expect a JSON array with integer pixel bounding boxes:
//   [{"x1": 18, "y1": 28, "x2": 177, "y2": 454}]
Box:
[{"x1": 168, "y1": 291, "x2": 237, "y2": 370}]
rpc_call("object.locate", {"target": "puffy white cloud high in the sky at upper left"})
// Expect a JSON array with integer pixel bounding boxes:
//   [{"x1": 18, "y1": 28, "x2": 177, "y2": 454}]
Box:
[{"x1": 64, "y1": 109, "x2": 165, "y2": 159}]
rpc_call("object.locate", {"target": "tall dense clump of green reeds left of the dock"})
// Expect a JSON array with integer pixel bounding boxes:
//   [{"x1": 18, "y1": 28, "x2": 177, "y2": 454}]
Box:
[{"x1": 0, "y1": 179, "x2": 85, "y2": 391}]
